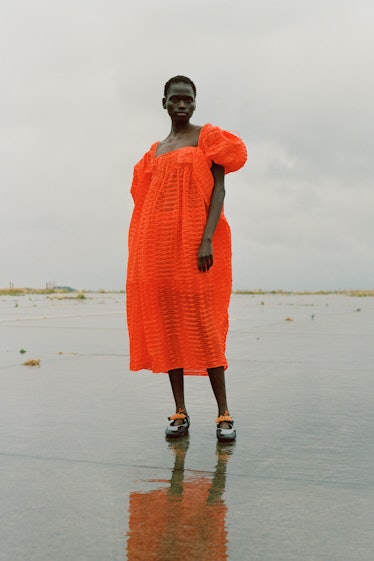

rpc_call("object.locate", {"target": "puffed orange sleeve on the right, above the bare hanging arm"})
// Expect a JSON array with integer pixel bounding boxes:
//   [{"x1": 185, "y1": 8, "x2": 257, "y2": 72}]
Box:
[{"x1": 199, "y1": 124, "x2": 247, "y2": 173}]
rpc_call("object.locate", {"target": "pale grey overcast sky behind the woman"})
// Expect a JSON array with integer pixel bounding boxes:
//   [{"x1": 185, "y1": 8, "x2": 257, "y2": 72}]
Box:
[{"x1": 0, "y1": 0, "x2": 374, "y2": 290}]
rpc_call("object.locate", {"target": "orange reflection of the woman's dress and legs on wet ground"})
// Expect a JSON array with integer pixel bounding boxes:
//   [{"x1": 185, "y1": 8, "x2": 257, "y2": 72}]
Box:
[{"x1": 127, "y1": 436, "x2": 233, "y2": 561}]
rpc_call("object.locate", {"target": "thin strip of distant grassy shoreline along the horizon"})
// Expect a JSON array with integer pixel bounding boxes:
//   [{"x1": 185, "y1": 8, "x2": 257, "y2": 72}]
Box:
[{"x1": 0, "y1": 287, "x2": 374, "y2": 298}]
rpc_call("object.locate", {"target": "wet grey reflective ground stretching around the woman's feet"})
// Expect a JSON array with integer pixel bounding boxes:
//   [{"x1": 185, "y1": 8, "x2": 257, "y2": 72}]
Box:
[{"x1": 0, "y1": 294, "x2": 374, "y2": 561}]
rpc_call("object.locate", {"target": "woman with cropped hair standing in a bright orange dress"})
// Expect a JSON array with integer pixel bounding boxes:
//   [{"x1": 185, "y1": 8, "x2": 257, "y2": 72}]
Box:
[{"x1": 126, "y1": 76, "x2": 247, "y2": 441}]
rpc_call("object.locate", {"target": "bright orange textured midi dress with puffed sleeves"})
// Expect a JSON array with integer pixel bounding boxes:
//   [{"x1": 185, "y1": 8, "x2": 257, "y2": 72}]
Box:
[{"x1": 126, "y1": 124, "x2": 247, "y2": 376}]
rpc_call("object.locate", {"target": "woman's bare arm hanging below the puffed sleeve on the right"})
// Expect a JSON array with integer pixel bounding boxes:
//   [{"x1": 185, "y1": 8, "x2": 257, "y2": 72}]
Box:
[{"x1": 197, "y1": 162, "x2": 225, "y2": 273}]
